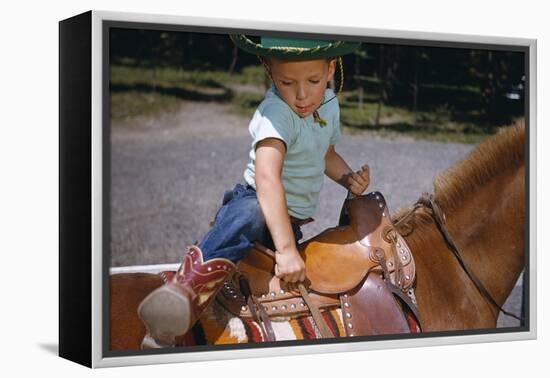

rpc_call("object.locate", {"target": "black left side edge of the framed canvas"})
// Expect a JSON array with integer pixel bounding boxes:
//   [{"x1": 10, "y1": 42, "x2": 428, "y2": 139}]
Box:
[{"x1": 59, "y1": 11, "x2": 92, "y2": 367}]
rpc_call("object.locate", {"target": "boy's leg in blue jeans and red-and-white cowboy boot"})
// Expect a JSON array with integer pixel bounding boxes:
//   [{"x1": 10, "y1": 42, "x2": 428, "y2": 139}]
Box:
[{"x1": 138, "y1": 185, "x2": 292, "y2": 347}]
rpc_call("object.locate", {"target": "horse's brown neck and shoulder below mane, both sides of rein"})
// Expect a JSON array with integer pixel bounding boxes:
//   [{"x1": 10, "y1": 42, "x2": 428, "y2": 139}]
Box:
[{"x1": 407, "y1": 162, "x2": 525, "y2": 330}]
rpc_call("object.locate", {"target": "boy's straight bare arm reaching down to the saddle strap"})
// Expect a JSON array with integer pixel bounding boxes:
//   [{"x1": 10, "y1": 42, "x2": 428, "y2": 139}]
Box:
[{"x1": 255, "y1": 138, "x2": 305, "y2": 282}]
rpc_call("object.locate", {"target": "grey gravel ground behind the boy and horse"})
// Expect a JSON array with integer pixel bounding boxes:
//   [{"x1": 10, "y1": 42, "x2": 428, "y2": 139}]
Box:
[{"x1": 111, "y1": 102, "x2": 521, "y2": 326}]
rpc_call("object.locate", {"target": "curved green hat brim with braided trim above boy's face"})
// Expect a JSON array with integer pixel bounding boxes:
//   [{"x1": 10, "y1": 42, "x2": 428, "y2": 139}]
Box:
[{"x1": 229, "y1": 34, "x2": 361, "y2": 60}]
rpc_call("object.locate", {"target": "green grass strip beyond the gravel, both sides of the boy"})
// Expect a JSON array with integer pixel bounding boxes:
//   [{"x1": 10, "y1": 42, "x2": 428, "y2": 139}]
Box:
[{"x1": 111, "y1": 65, "x2": 516, "y2": 143}]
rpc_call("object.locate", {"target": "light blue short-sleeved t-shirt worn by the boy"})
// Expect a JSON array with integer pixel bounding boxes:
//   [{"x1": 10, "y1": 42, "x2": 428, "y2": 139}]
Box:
[{"x1": 244, "y1": 86, "x2": 341, "y2": 219}]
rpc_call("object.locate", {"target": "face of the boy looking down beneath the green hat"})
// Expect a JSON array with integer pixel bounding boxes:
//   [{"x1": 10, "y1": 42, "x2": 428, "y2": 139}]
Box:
[{"x1": 267, "y1": 59, "x2": 336, "y2": 118}]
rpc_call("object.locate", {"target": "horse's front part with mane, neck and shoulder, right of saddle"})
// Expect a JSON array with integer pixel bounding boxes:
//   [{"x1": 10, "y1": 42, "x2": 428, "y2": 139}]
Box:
[{"x1": 395, "y1": 124, "x2": 526, "y2": 331}]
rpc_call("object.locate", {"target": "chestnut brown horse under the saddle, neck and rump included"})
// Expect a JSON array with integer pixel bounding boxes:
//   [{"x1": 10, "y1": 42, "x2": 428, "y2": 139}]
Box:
[{"x1": 110, "y1": 125, "x2": 525, "y2": 350}]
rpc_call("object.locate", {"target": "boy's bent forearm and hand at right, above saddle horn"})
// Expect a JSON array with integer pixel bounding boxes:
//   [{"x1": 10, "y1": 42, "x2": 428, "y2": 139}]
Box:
[{"x1": 325, "y1": 144, "x2": 370, "y2": 195}]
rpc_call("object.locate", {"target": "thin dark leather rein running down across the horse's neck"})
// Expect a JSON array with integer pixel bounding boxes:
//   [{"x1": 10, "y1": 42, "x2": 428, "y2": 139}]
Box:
[{"x1": 394, "y1": 193, "x2": 524, "y2": 322}]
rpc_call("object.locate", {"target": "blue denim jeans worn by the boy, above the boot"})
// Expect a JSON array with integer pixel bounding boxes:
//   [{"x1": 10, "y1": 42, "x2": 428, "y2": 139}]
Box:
[{"x1": 199, "y1": 184, "x2": 302, "y2": 263}]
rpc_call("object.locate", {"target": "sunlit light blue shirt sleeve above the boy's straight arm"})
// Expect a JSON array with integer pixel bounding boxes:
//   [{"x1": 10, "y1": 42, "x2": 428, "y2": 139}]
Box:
[{"x1": 249, "y1": 102, "x2": 296, "y2": 150}]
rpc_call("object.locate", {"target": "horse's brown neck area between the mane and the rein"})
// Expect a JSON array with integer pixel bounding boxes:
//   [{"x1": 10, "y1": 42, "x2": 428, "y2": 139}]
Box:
[{"x1": 447, "y1": 165, "x2": 525, "y2": 304}]
